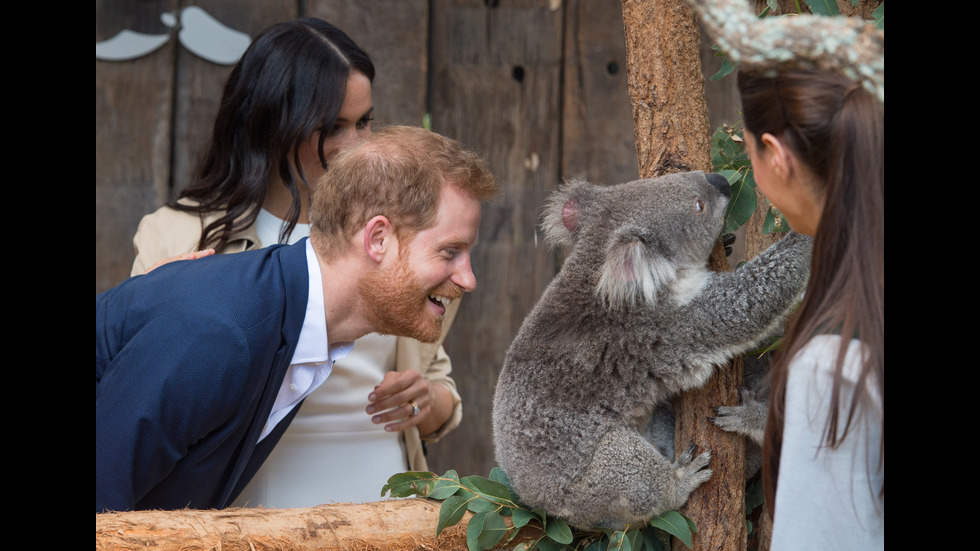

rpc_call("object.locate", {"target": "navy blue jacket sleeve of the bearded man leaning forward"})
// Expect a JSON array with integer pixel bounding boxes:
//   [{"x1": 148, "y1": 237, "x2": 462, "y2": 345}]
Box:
[{"x1": 95, "y1": 308, "x2": 251, "y2": 513}]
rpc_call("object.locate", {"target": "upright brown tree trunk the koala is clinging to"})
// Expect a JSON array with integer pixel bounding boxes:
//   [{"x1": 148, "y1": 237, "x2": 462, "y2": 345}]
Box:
[{"x1": 623, "y1": 0, "x2": 746, "y2": 549}]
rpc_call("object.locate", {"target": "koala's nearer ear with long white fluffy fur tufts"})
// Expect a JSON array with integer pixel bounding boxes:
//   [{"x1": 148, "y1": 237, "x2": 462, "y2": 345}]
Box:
[{"x1": 596, "y1": 227, "x2": 677, "y2": 308}]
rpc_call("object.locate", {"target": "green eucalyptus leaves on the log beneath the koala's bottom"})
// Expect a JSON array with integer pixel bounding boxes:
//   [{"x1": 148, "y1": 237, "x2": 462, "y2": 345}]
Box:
[{"x1": 381, "y1": 467, "x2": 697, "y2": 551}]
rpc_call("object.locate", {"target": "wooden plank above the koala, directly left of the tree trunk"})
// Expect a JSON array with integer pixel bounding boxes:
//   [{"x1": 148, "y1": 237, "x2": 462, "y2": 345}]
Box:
[{"x1": 562, "y1": 0, "x2": 639, "y2": 184}]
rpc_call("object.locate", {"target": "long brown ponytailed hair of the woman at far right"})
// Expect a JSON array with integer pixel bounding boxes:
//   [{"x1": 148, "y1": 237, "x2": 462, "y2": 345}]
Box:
[{"x1": 738, "y1": 70, "x2": 885, "y2": 507}]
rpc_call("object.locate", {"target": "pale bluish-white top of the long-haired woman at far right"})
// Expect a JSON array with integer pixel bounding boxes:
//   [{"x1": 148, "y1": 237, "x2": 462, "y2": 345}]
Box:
[{"x1": 770, "y1": 335, "x2": 885, "y2": 551}]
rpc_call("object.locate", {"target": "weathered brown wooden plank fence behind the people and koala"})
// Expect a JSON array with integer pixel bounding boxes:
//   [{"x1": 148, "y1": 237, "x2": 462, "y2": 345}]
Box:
[{"x1": 95, "y1": 0, "x2": 737, "y2": 476}]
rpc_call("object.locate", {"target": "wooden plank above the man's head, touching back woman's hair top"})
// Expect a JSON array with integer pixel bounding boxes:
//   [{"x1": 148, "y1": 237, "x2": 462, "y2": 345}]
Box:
[{"x1": 307, "y1": 0, "x2": 429, "y2": 126}]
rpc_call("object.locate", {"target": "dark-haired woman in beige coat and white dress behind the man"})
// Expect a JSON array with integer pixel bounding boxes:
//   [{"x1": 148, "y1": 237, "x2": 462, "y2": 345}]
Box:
[{"x1": 133, "y1": 19, "x2": 462, "y2": 507}]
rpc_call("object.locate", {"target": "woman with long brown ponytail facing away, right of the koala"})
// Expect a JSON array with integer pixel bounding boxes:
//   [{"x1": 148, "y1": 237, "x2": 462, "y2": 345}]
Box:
[{"x1": 738, "y1": 70, "x2": 885, "y2": 551}]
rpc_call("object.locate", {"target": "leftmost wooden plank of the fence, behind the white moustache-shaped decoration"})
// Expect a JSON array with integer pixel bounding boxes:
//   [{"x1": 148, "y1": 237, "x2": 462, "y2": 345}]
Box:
[{"x1": 95, "y1": 0, "x2": 176, "y2": 293}]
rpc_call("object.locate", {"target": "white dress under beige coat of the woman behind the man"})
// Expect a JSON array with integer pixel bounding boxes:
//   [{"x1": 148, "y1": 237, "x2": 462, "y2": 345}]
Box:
[{"x1": 232, "y1": 210, "x2": 408, "y2": 508}]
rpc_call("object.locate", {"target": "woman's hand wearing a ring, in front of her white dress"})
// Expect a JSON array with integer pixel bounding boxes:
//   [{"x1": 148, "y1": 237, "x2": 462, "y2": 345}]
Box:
[{"x1": 366, "y1": 369, "x2": 452, "y2": 436}]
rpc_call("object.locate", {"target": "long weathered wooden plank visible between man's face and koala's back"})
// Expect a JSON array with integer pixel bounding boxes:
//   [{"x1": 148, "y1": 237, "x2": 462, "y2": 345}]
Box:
[{"x1": 429, "y1": 0, "x2": 564, "y2": 476}]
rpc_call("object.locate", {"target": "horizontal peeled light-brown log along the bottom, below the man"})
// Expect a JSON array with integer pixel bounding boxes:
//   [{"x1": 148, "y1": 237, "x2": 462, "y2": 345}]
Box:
[{"x1": 95, "y1": 499, "x2": 540, "y2": 551}]
